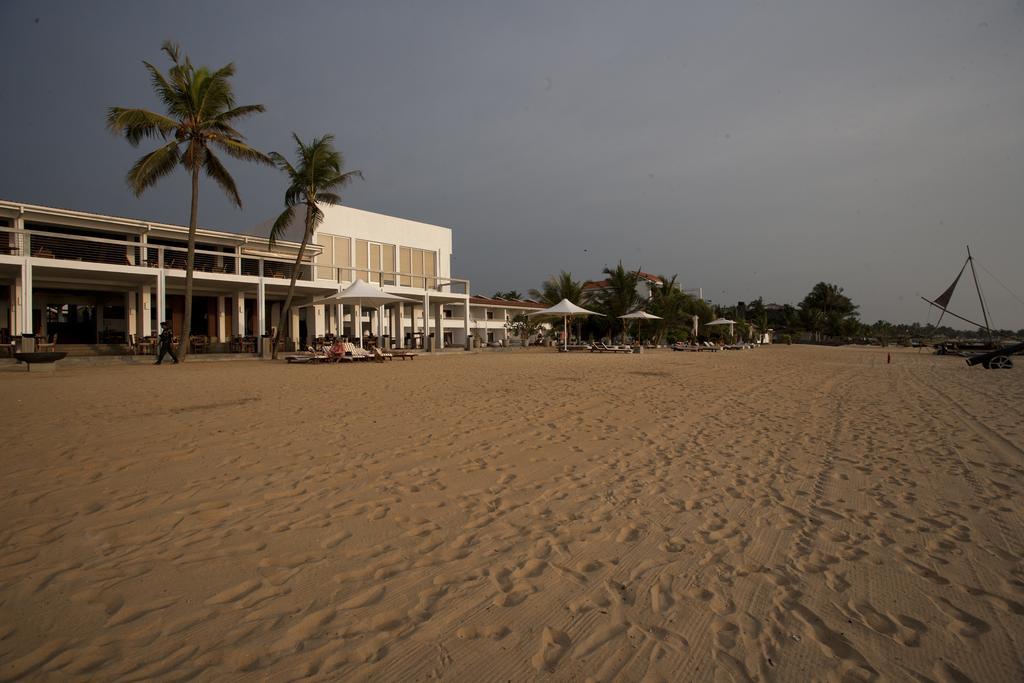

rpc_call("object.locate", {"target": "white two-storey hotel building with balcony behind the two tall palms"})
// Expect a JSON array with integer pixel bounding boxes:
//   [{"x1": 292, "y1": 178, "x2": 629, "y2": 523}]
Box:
[{"x1": 0, "y1": 201, "x2": 497, "y2": 354}]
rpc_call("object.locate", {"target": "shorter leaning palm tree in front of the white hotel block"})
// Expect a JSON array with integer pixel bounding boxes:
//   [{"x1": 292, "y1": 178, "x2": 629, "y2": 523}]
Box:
[{"x1": 270, "y1": 133, "x2": 362, "y2": 358}]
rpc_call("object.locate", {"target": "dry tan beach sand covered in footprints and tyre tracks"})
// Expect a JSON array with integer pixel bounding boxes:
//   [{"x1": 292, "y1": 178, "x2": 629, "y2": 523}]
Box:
[{"x1": 0, "y1": 346, "x2": 1024, "y2": 682}]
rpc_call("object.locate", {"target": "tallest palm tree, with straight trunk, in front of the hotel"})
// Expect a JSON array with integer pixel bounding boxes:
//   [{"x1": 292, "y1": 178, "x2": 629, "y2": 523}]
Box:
[{"x1": 106, "y1": 41, "x2": 270, "y2": 360}]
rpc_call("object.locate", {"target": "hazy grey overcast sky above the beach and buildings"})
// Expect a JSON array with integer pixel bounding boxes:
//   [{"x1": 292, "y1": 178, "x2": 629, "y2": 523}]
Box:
[{"x1": 0, "y1": 0, "x2": 1024, "y2": 330}]
